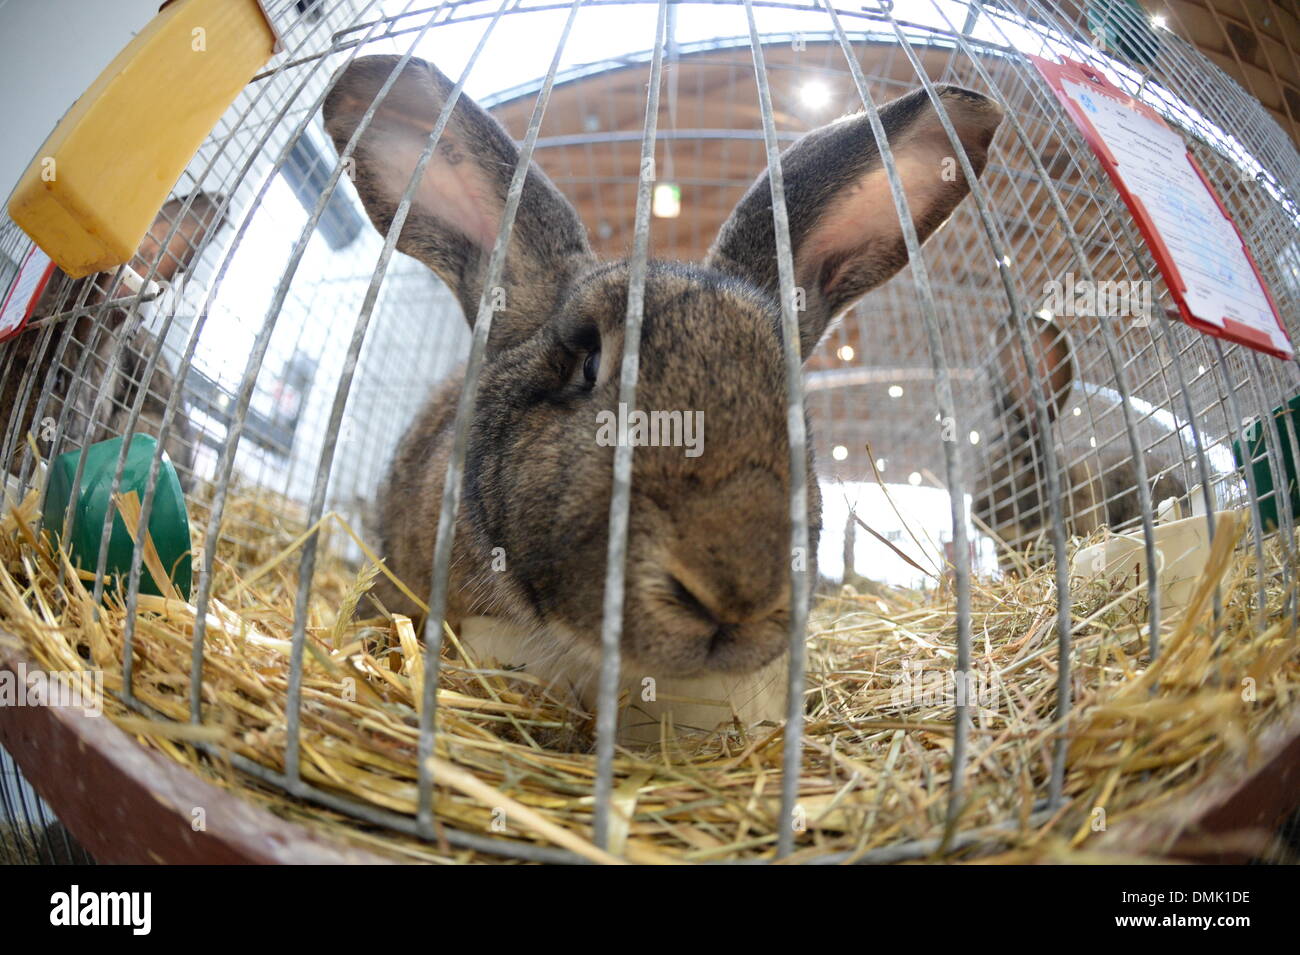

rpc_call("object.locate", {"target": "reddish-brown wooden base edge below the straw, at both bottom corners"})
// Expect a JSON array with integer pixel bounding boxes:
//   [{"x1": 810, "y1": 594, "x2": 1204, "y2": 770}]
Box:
[{"x1": 0, "y1": 634, "x2": 1300, "y2": 864}]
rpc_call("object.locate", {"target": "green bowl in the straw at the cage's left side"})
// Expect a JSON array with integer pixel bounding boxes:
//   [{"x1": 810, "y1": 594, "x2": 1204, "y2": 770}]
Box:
[{"x1": 40, "y1": 434, "x2": 192, "y2": 599}]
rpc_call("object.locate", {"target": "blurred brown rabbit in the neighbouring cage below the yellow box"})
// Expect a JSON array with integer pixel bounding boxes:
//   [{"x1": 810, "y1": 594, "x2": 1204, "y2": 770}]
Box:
[{"x1": 0, "y1": 192, "x2": 221, "y2": 486}]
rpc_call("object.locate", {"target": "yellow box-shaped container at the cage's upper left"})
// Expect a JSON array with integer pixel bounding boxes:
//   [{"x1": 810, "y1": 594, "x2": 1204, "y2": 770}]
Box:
[{"x1": 9, "y1": 0, "x2": 276, "y2": 277}]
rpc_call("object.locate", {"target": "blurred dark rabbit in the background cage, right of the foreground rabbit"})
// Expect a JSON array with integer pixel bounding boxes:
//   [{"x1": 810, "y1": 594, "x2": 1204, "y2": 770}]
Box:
[{"x1": 974, "y1": 318, "x2": 1187, "y2": 569}]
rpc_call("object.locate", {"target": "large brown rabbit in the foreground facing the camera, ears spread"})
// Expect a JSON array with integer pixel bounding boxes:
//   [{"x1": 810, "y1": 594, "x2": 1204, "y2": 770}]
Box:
[{"x1": 324, "y1": 56, "x2": 1002, "y2": 728}]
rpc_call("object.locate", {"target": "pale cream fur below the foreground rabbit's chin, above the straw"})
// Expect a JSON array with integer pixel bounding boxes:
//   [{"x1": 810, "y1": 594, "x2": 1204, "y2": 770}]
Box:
[{"x1": 460, "y1": 617, "x2": 787, "y2": 743}]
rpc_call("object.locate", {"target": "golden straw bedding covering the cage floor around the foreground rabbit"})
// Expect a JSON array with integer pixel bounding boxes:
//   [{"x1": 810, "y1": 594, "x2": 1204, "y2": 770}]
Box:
[{"x1": 0, "y1": 480, "x2": 1300, "y2": 861}]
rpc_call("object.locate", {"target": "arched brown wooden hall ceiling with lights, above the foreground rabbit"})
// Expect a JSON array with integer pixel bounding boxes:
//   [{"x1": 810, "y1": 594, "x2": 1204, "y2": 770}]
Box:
[{"x1": 493, "y1": 10, "x2": 1300, "y2": 283}]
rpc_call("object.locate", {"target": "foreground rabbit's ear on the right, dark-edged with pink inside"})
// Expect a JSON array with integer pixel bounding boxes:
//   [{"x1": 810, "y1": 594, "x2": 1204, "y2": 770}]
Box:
[{"x1": 705, "y1": 86, "x2": 1002, "y2": 356}]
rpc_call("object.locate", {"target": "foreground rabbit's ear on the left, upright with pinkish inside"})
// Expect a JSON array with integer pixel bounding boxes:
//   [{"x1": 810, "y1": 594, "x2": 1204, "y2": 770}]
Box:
[{"x1": 324, "y1": 56, "x2": 593, "y2": 347}]
